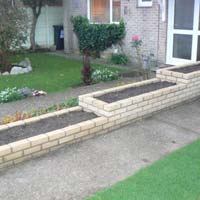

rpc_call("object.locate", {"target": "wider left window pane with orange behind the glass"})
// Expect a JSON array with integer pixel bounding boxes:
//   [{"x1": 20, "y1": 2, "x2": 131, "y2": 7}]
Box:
[{"x1": 91, "y1": 0, "x2": 110, "y2": 23}]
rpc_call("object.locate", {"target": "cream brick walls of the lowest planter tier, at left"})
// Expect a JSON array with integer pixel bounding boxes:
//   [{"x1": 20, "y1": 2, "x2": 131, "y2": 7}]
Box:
[{"x1": 0, "y1": 107, "x2": 110, "y2": 168}]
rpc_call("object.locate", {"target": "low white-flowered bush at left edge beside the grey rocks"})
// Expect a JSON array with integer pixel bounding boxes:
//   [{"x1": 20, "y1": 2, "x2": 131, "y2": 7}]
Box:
[{"x1": 0, "y1": 87, "x2": 24, "y2": 103}]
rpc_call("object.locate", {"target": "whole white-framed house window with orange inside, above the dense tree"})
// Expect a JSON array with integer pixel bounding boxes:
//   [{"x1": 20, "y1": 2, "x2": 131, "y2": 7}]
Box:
[{"x1": 88, "y1": 0, "x2": 121, "y2": 23}]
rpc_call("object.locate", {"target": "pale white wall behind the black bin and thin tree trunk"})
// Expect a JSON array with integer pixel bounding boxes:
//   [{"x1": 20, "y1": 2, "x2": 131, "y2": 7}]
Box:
[{"x1": 26, "y1": 6, "x2": 64, "y2": 47}]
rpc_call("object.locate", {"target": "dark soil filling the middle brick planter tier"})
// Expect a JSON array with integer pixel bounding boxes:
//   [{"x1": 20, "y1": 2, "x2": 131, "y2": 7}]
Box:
[{"x1": 96, "y1": 81, "x2": 176, "y2": 103}]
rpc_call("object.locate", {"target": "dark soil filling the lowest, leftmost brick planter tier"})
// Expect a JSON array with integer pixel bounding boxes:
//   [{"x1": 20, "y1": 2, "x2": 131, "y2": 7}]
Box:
[{"x1": 0, "y1": 111, "x2": 97, "y2": 145}]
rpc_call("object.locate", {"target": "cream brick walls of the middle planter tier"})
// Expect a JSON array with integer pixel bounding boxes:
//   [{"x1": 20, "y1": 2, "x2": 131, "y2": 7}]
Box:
[{"x1": 79, "y1": 79, "x2": 187, "y2": 119}]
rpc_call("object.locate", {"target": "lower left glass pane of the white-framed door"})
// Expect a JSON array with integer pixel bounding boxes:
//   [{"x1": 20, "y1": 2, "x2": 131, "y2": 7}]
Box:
[{"x1": 173, "y1": 34, "x2": 192, "y2": 60}]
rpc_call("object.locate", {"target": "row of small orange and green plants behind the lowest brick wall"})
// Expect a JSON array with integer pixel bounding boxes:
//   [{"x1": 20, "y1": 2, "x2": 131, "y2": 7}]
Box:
[{"x1": 2, "y1": 98, "x2": 78, "y2": 124}]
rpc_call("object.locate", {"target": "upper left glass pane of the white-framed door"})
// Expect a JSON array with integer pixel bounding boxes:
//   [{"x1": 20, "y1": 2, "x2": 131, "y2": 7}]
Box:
[{"x1": 174, "y1": 0, "x2": 194, "y2": 30}]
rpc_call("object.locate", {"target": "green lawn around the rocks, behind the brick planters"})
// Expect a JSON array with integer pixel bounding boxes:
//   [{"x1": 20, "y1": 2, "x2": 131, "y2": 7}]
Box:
[{"x1": 0, "y1": 53, "x2": 125, "y2": 93}]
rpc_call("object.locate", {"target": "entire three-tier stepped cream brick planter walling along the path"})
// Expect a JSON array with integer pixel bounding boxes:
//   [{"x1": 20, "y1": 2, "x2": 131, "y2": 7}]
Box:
[{"x1": 0, "y1": 63, "x2": 200, "y2": 168}]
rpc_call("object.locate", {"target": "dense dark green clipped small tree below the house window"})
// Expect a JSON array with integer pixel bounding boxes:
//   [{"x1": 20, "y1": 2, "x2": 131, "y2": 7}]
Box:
[{"x1": 71, "y1": 16, "x2": 125, "y2": 85}]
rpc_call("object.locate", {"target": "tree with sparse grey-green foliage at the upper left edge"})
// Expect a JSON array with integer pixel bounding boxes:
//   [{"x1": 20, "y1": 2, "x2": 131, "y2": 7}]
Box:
[{"x1": 0, "y1": 0, "x2": 28, "y2": 68}]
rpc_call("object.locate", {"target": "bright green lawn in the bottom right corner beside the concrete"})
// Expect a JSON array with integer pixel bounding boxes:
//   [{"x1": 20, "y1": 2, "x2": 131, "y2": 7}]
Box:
[{"x1": 88, "y1": 140, "x2": 200, "y2": 200}]
